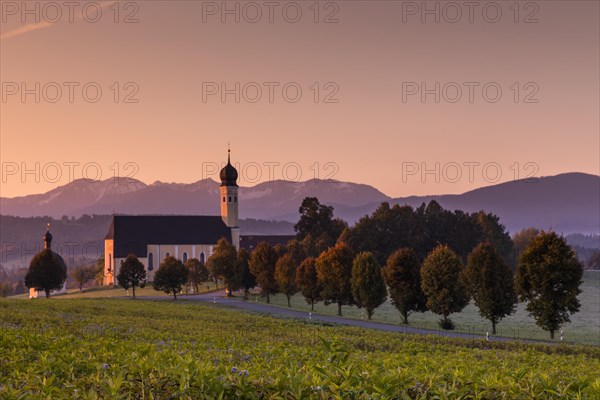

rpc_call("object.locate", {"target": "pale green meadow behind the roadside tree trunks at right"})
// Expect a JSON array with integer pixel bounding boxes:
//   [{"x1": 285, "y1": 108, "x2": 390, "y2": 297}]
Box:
[{"x1": 251, "y1": 271, "x2": 600, "y2": 346}]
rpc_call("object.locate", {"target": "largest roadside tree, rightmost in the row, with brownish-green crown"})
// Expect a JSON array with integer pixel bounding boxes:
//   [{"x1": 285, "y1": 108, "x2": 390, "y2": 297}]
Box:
[{"x1": 515, "y1": 231, "x2": 583, "y2": 339}]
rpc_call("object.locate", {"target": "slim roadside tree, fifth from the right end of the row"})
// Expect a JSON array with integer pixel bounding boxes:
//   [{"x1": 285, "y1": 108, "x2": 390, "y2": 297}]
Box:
[{"x1": 352, "y1": 252, "x2": 387, "y2": 319}]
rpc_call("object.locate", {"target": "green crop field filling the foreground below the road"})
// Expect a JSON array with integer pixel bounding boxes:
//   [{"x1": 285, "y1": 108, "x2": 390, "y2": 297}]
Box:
[{"x1": 0, "y1": 299, "x2": 600, "y2": 399}]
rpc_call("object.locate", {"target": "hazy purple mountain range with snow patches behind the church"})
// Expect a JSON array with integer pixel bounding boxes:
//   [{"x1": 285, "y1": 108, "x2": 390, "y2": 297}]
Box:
[{"x1": 0, "y1": 173, "x2": 600, "y2": 234}]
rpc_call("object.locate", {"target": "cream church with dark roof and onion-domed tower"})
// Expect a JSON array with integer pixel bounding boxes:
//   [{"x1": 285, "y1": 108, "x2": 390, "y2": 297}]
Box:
[{"x1": 104, "y1": 151, "x2": 241, "y2": 286}]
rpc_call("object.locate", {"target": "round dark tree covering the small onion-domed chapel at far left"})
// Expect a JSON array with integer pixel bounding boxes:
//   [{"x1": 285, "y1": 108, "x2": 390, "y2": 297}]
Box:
[{"x1": 25, "y1": 249, "x2": 67, "y2": 298}]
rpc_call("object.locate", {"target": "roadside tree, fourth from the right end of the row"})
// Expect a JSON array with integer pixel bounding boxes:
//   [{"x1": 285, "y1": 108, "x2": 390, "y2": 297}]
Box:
[{"x1": 383, "y1": 247, "x2": 427, "y2": 324}]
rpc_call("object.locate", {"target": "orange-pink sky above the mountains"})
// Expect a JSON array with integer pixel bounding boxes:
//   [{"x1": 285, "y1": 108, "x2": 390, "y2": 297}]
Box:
[{"x1": 0, "y1": 1, "x2": 600, "y2": 197}]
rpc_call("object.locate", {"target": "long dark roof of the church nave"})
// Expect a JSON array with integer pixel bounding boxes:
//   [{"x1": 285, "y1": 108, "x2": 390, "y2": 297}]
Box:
[{"x1": 105, "y1": 215, "x2": 231, "y2": 258}]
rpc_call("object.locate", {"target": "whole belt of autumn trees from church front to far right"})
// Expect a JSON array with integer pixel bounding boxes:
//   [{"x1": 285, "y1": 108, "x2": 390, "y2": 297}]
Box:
[{"x1": 21, "y1": 197, "x2": 583, "y2": 338}]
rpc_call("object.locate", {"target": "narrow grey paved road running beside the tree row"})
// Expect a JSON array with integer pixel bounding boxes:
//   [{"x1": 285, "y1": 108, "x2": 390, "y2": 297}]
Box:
[{"x1": 148, "y1": 290, "x2": 513, "y2": 341}]
